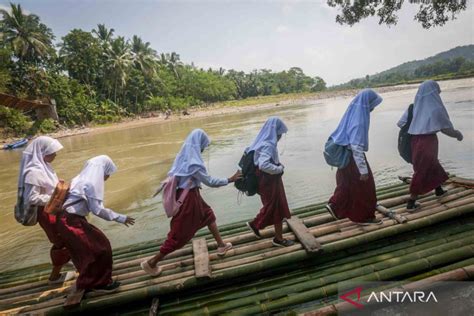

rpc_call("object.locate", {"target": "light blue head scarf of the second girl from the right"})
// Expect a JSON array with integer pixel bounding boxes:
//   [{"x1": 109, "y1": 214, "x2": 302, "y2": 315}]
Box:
[{"x1": 331, "y1": 89, "x2": 383, "y2": 151}]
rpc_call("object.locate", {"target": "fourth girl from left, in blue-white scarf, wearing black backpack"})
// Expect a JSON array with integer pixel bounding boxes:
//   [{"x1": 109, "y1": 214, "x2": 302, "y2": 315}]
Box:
[{"x1": 245, "y1": 117, "x2": 294, "y2": 247}]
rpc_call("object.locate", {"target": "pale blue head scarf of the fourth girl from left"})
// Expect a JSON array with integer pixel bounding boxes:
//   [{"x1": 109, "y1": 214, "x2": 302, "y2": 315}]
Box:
[{"x1": 245, "y1": 116, "x2": 288, "y2": 165}]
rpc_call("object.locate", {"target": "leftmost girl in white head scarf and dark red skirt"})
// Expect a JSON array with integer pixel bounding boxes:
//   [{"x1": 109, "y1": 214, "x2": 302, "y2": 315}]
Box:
[{"x1": 17, "y1": 136, "x2": 75, "y2": 284}]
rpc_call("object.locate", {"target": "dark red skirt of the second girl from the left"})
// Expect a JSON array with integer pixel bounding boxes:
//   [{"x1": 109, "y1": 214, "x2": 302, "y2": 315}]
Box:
[{"x1": 56, "y1": 211, "x2": 112, "y2": 290}]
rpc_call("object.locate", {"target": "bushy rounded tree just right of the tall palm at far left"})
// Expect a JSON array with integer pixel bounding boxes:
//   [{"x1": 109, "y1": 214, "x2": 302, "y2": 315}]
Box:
[{"x1": 59, "y1": 29, "x2": 102, "y2": 85}]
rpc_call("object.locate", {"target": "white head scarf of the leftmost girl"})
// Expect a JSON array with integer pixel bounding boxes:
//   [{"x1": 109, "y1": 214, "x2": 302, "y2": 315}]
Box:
[{"x1": 18, "y1": 136, "x2": 63, "y2": 194}]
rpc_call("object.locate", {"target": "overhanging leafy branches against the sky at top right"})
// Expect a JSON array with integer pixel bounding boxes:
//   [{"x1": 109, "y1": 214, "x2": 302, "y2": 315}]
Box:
[{"x1": 327, "y1": 0, "x2": 467, "y2": 29}]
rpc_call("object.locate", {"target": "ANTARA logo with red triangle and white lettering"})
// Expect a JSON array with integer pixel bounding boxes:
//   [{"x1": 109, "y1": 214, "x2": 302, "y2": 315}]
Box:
[{"x1": 339, "y1": 286, "x2": 438, "y2": 309}]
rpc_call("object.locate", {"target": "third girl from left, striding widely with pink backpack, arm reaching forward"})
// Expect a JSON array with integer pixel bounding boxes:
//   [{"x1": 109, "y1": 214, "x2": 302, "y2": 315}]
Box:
[{"x1": 140, "y1": 129, "x2": 241, "y2": 276}]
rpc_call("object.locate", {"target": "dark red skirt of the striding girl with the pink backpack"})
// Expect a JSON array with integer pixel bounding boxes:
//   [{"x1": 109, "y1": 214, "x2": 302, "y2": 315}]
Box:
[{"x1": 160, "y1": 187, "x2": 216, "y2": 255}]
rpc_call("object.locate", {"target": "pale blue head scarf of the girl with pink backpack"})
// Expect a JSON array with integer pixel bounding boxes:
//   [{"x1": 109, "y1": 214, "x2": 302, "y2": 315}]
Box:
[{"x1": 168, "y1": 128, "x2": 211, "y2": 177}]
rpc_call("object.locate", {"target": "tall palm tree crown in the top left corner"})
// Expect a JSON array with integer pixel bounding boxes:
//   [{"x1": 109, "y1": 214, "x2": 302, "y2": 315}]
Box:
[{"x1": 0, "y1": 3, "x2": 54, "y2": 62}]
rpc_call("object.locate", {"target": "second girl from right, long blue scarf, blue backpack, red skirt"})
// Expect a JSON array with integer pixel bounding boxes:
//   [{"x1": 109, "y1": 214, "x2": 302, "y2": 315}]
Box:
[{"x1": 326, "y1": 89, "x2": 382, "y2": 225}]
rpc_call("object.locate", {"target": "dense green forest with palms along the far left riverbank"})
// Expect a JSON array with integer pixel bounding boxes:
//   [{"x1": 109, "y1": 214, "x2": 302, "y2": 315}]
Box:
[{"x1": 0, "y1": 4, "x2": 326, "y2": 135}]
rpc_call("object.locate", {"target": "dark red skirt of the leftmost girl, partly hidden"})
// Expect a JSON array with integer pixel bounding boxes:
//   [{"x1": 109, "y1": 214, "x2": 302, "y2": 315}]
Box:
[{"x1": 38, "y1": 206, "x2": 71, "y2": 267}]
